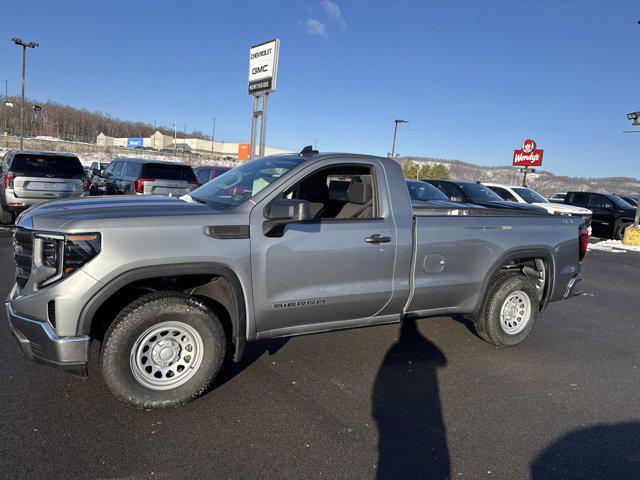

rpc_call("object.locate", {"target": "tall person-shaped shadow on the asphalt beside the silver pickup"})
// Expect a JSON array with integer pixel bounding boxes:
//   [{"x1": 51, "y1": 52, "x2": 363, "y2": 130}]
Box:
[{"x1": 373, "y1": 320, "x2": 450, "y2": 479}]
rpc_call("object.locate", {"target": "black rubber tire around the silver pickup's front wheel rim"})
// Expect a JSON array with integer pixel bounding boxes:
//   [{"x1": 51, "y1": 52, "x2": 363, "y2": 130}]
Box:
[{"x1": 100, "y1": 292, "x2": 226, "y2": 409}]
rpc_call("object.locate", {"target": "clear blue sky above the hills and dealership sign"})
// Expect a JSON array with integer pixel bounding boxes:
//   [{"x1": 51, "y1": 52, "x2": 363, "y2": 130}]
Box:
[{"x1": 0, "y1": 0, "x2": 640, "y2": 177}]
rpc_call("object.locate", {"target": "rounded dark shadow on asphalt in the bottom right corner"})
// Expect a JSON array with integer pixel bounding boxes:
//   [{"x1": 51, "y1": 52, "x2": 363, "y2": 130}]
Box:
[{"x1": 531, "y1": 422, "x2": 640, "y2": 480}]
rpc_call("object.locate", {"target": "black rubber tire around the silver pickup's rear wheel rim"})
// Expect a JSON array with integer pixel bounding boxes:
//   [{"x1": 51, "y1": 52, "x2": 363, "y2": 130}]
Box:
[{"x1": 475, "y1": 272, "x2": 539, "y2": 347}]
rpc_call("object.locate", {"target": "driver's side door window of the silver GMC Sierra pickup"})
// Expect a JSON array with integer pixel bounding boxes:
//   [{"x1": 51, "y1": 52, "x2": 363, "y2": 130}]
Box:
[{"x1": 285, "y1": 165, "x2": 378, "y2": 220}]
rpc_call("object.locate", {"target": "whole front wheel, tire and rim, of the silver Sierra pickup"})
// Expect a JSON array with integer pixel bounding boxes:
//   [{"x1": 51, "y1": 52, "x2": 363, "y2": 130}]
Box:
[{"x1": 100, "y1": 292, "x2": 226, "y2": 408}]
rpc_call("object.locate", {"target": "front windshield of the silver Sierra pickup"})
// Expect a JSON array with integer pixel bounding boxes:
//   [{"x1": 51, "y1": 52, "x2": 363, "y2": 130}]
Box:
[{"x1": 190, "y1": 157, "x2": 305, "y2": 208}]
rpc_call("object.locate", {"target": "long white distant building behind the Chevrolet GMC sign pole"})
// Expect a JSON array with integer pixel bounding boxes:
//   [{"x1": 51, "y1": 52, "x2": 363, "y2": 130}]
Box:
[{"x1": 96, "y1": 132, "x2": 291, "y2": 158}]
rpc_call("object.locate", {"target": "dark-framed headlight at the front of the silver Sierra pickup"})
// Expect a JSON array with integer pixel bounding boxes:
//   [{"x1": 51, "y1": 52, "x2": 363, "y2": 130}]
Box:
[{"x1": 34, "y1": 233, "x2": 101, "y2": 287}]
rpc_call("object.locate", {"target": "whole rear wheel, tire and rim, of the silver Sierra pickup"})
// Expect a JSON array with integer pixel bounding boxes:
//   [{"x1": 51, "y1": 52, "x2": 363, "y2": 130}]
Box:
[{"x1": 475, "y1": 272, "x2": 538, "y2": 347}]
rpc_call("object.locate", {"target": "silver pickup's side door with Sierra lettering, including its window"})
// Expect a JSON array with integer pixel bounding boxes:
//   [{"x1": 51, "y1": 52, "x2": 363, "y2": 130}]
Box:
[{"x1": 251, "y1": 159, "x2": 396, "y2": 336}]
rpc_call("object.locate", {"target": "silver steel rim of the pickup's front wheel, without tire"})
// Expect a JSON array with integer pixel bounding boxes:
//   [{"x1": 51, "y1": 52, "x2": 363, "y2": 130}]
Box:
[{"x1": 129, "y1": 322, "x2": 204, "y2": 390}]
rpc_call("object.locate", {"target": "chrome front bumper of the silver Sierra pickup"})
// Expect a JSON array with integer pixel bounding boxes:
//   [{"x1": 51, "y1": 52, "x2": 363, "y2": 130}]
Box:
[{"x1": 6, "y1": 302, "x2": 90, "y2": 377}]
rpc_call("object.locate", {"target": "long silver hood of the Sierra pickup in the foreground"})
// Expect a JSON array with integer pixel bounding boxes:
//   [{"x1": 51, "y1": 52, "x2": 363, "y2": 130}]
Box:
[{"x1": 16, "y1": 195, "x2": 213, "y2": 231}]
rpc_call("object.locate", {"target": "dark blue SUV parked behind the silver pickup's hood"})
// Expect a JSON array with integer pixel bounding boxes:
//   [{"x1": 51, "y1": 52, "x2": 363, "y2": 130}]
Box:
[{"x1": 102, "y1": 158, "x2": 199, "y2": 196}]
